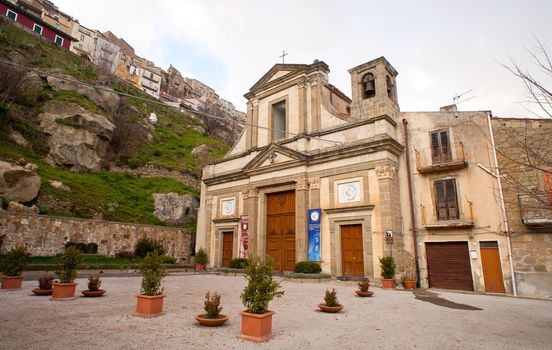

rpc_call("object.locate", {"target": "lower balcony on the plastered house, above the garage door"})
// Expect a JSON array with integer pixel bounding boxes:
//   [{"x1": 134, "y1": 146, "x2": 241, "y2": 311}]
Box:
[{"x1": 420, "y1": 201, "x2": 474, "y2": 230}]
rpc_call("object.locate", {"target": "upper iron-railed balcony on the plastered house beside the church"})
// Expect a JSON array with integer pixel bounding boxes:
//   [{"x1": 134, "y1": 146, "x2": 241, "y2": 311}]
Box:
[{"x1": 414, "y1": 142, "x2": 468, "y2": 174}]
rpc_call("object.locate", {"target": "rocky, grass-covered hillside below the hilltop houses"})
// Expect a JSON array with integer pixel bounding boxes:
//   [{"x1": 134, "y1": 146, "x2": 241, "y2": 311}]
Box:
[{"x1": 0, "y1": 21, "x2": 229, "y2": 226}]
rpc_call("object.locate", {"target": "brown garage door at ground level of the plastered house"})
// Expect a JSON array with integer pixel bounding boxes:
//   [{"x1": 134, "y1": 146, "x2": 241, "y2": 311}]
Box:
[{"x1": 426, "y1": 242, "x2": 473, "y2": 291}]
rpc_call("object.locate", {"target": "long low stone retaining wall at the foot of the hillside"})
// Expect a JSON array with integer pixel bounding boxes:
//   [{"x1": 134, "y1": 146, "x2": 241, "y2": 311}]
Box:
[{"x1": 0, "y1": 213, "x2": 192, "y2": 263}]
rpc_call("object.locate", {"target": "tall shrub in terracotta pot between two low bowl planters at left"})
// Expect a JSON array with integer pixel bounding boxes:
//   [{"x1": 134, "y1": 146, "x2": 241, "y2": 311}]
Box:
[{"x1": 52, "y1": 246, "x2": 82, "y2": 301}]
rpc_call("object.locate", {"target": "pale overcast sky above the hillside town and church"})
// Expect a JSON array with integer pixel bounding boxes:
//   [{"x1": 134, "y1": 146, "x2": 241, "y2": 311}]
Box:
[{"x1": 54, "y1": 0, "x2": 552, "y2": 117}]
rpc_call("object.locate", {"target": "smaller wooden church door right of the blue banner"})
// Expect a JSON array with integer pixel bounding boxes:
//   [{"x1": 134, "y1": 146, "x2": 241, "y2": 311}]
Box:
[{"x1": 341, "y1": 225, "x2": 364, "y2": 277}]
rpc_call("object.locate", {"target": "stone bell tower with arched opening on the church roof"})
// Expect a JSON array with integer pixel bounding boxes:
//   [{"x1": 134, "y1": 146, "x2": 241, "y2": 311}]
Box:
[{"x1": 349, "y1": 56, "x2": 399, "y2": 118}]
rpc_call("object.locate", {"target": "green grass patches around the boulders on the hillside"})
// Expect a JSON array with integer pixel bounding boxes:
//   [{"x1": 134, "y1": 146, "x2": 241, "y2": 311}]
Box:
[{"x1": 0, "y1": 23, "x2": 228, "y2": 224}]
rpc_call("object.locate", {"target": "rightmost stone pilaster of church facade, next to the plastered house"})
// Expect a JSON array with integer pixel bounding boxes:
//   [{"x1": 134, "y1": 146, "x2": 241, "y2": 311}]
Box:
[{"x1": 376, "y1": 164, "x2": 404, "y2": 272}]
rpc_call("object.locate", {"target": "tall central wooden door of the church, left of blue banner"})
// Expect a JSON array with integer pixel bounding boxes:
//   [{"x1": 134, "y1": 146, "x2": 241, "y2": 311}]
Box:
[{"x1": 266, "y1": 191, "x2": 295, "y2": 271}]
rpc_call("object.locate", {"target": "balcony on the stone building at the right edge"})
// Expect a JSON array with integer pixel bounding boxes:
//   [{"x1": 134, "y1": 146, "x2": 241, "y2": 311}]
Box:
[{"x1": 518, "y1": 192, "x2": 552, "y2": 227}]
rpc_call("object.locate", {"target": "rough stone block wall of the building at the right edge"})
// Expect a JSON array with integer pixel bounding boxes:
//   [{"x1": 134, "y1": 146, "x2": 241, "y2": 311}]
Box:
[{"x1": 492, "y1": 118, "x2": 552, "y2": 297}]
